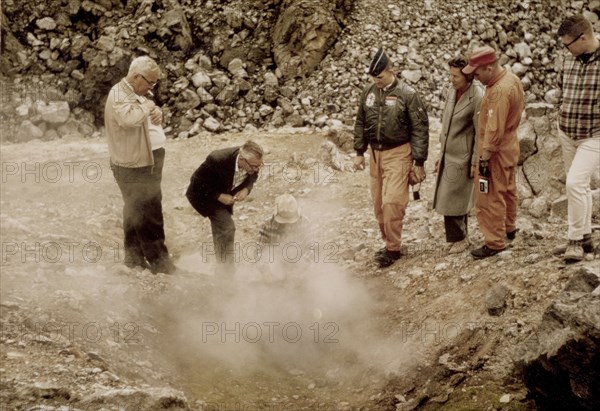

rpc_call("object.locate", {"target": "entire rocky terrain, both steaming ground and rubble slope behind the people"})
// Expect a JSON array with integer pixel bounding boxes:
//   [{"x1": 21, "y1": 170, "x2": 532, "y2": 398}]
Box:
[{"x1": 0, "y1": 0, "x2": 600, "y2": 411}]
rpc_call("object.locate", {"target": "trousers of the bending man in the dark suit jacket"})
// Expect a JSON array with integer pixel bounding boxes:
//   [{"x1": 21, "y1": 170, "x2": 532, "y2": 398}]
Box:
[{"x1": 208, "y1": 207, "x2": 235, "y2": 273}]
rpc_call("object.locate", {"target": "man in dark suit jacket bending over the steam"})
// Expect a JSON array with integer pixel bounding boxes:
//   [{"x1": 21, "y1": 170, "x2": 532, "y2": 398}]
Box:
[{"x1": 186, "y1": 140, "x2": 263, "y2": 272}]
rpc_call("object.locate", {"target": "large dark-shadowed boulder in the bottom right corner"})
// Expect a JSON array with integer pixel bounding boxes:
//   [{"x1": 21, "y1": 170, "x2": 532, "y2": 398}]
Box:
[{"x1": 516, "y1": 266, "x2": 600, "y2": 410}]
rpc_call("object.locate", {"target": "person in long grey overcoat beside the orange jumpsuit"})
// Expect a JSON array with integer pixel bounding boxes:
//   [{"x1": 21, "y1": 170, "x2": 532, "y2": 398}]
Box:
[{"x1": 433, "y1": 56, "x2": 484, "y2": 254}]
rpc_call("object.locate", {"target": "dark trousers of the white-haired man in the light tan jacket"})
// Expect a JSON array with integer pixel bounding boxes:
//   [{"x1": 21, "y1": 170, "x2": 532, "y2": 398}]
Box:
[{"x1": 111, "y1": 148, "x2": 169, "y2": 264}]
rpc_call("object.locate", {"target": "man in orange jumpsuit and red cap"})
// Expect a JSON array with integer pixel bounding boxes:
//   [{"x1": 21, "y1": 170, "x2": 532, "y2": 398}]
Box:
[{"x1": 462, "y1": 46, "x2": 524, "y2": 259}]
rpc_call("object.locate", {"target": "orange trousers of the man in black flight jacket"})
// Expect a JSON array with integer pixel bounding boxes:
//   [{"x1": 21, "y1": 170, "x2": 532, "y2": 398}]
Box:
[{"x1": 369, "y1": 143, "x2": 412, "y2": 251}]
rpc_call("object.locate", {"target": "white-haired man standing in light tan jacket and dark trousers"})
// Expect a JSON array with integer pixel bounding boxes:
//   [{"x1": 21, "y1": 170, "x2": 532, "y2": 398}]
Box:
[{"x1": 104, "y1": 56, "x2": 175, "y2": 274}]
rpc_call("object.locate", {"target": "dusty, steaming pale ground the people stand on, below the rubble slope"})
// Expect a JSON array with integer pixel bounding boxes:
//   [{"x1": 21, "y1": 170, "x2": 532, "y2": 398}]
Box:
[{"x1": 0, "y1": 122, "x2": 598, "y2": 410}]
